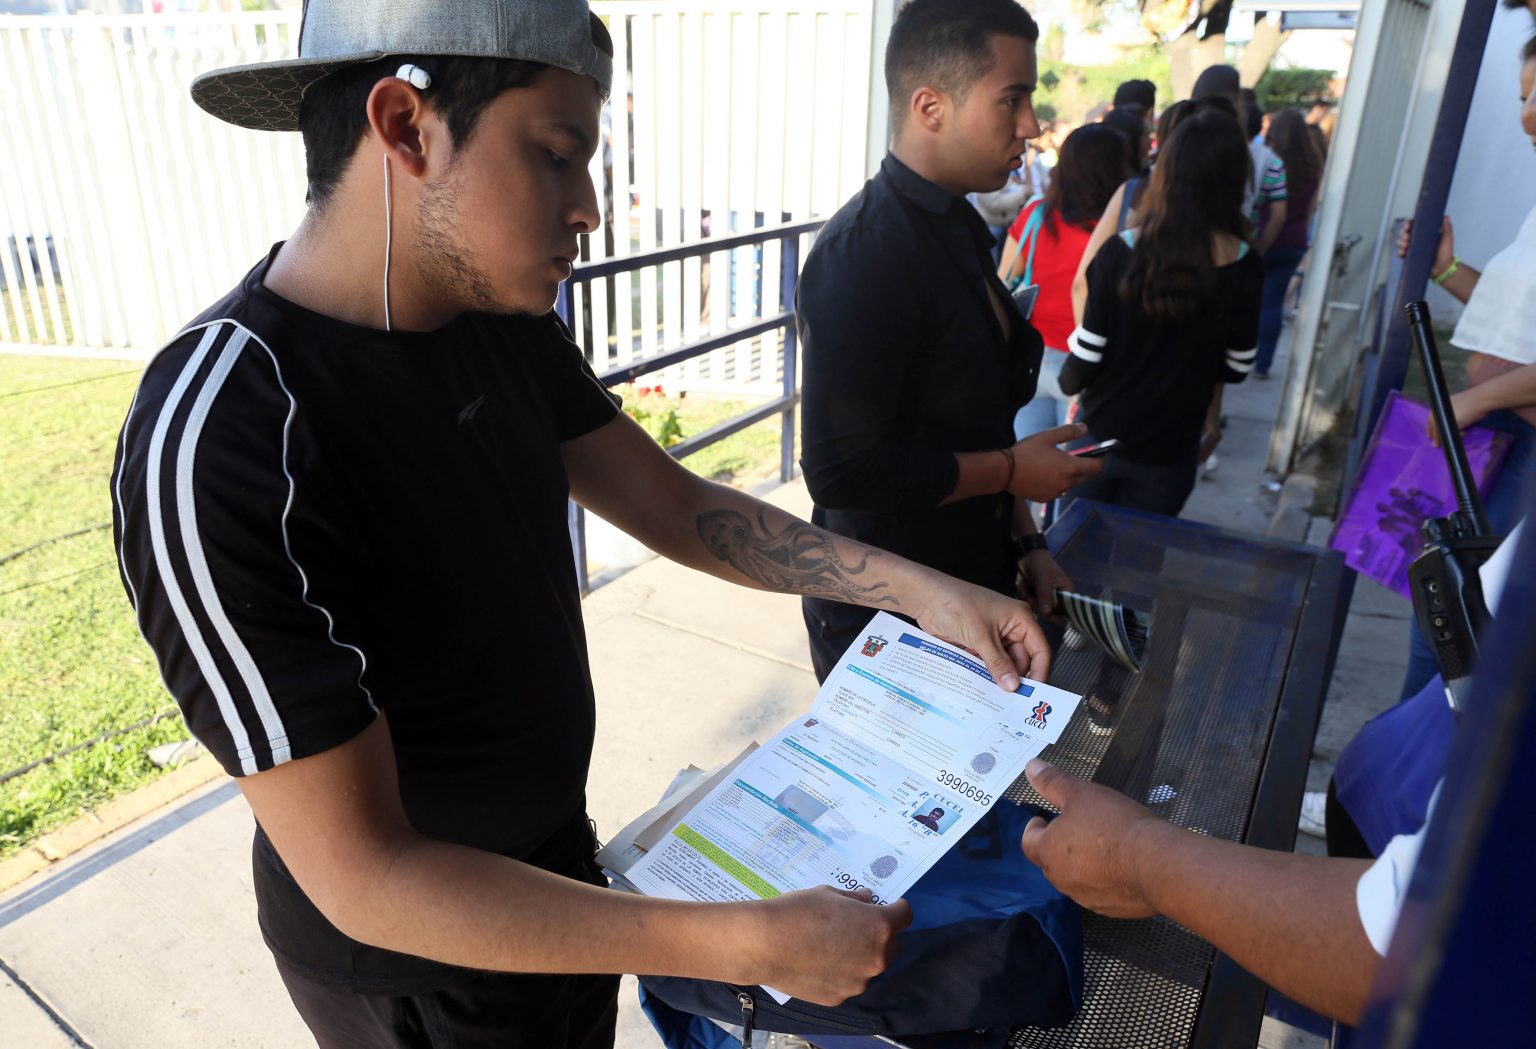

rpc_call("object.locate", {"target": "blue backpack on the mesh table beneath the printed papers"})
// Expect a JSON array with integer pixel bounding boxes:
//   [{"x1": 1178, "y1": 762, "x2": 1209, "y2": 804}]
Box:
[{"x1": 641, "y1": 800, "x2": 1083, "y2": 1049}]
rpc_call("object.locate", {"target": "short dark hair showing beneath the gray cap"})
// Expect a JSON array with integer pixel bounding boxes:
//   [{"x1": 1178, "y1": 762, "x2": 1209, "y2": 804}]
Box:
[{"x1": 298, "y1": 15, "x2": 613, "y2": 210}]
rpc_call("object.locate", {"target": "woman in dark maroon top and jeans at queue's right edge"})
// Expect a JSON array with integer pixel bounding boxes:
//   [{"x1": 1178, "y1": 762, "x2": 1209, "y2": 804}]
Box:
[{"x1": 1253, "y1": 109, "x2": 1322, "y2": 379}]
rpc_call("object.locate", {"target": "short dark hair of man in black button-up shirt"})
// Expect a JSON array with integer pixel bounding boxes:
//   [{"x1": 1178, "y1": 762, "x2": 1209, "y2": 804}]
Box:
[{"x1": 885, "y1": 0, "x2": 1040, "y2": 127}]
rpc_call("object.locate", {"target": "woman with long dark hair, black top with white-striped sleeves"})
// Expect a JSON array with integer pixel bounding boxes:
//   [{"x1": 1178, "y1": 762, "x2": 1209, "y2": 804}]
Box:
[{"x1": 1061, "y1": 111, "x2": 1264, "y2": 515}]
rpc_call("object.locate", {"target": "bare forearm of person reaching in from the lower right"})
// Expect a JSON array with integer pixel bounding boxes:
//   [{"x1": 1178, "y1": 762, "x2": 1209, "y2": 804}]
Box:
[{"x1": 1132, "y1": 822, "x2": 1381, "y2": 1023}]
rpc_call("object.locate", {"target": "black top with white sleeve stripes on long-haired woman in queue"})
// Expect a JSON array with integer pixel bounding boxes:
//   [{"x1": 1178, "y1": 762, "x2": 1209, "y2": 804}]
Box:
[{"x1": 1060, "y1": 233, "x2": 1264, "y2": 464}]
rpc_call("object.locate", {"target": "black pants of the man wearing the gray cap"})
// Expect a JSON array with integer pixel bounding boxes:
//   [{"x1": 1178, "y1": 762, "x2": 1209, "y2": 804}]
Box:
[{"x1": 276, "y1": 958, "x2": 619, "y2": 1049}]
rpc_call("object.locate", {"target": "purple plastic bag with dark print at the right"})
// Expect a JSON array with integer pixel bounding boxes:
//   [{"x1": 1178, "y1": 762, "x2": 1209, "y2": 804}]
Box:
[{"x1": 1329, "y1": 390, "x2": 1510, "y2": 601}]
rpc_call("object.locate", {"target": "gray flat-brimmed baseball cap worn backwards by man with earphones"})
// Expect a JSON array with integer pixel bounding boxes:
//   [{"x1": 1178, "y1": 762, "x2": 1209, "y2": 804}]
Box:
[{"x1": 192, "y1": 0, "x2": 613, "y2": 131}]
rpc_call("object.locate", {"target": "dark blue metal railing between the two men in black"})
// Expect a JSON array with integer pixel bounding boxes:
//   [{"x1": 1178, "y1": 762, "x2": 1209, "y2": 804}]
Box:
[{"x1": 554, "y1": 218, "x2": 826, "y2": 594}]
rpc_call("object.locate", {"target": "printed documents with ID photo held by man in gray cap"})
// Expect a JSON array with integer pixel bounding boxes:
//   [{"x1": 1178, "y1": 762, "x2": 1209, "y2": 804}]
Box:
[{"x1": 598, "y1": 613, "x2": 1080, "y2": 1007}]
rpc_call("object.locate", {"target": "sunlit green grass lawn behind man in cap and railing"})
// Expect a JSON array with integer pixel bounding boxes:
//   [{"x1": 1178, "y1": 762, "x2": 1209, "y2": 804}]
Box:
[{"x1": 0, "y1": 355, "x2": 779, "y2": 857}]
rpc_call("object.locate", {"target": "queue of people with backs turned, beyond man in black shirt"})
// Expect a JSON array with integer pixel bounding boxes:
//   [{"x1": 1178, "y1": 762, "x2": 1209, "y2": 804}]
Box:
[{"x1": 968, "y1": 66, "x2": 1333, "y2": 515}]
